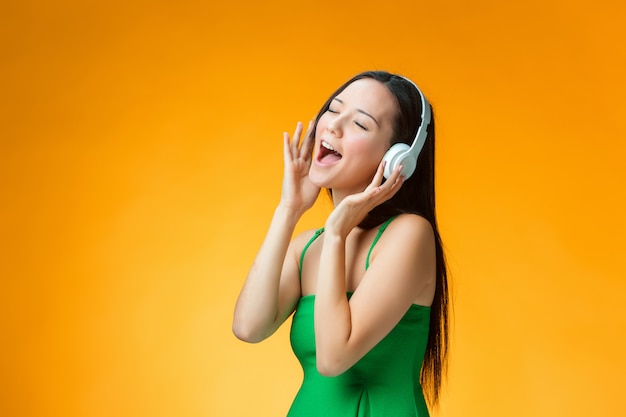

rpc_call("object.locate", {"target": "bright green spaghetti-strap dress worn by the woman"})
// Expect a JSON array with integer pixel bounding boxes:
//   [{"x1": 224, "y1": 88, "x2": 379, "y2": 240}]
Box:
[{"x1": 288, "y1": 218, "x2": 430, "y2": 417}]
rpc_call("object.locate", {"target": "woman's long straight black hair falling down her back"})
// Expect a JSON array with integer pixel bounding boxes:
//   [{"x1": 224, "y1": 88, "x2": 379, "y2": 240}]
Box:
[{"x1": 311, "y1": 71, "x2": 450, "y2": 407}]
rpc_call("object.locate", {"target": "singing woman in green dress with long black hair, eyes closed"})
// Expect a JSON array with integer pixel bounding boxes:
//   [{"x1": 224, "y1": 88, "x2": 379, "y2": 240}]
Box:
[{"x1": 233, "y1": 71, "x2": 448, "y2": 417}]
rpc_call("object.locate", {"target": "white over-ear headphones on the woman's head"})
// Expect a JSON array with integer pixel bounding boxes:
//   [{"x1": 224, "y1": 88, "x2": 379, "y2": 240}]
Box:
[{"x1": 383, "y1": 76, "x2": 431, "y2": 179}]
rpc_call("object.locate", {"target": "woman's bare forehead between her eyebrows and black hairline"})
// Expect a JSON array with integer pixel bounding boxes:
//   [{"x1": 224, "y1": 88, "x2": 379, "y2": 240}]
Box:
[{"x1": 337, "y1": 78, "x2": 398, "y2": 123}]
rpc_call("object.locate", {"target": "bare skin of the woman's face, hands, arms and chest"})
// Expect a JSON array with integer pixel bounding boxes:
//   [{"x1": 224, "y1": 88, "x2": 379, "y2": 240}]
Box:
[{"x1": 233, "y1": 79, "x2": 435, "y2": 376}]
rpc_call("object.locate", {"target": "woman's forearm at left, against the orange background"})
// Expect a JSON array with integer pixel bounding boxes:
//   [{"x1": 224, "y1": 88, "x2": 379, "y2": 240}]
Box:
[{"x1": 233, "y1": 205, "x2": 300, "y2": 342}]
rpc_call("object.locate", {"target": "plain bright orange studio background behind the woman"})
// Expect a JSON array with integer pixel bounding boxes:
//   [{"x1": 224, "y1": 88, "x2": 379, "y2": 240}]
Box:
[{"x1": 0, "y1": 0, "x2": 626, "y2": 417}]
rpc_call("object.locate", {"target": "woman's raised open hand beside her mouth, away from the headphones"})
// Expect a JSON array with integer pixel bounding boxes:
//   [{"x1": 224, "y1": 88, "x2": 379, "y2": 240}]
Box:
[{"x1": 280, "y1": 121, "x2": 320, "y2": 215}]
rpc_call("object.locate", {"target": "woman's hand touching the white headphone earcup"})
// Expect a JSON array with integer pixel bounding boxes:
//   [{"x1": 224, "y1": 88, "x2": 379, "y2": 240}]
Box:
[{"x1": 324, "y1": 161, "x2": 404, "y2": 239}]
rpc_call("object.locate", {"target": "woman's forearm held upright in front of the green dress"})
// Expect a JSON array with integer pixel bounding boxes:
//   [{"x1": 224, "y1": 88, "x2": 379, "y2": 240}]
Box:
[{"x1": 314, "y1": 232, "x2": 352, "y2": 375}]
